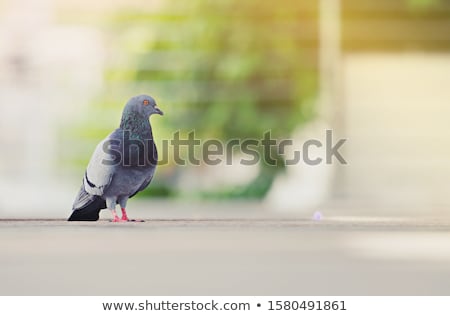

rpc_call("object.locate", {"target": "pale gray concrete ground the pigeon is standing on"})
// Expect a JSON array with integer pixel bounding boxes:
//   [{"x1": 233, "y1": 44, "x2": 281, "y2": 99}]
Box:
[{"x1": 0, "y1": 204, "x2": 450, "y2": 295}]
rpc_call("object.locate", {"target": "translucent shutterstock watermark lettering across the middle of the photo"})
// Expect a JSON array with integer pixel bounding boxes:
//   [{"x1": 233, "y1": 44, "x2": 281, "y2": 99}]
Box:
[{"x1": 102, "y1": 130, "x2": 347, "y2": 166}]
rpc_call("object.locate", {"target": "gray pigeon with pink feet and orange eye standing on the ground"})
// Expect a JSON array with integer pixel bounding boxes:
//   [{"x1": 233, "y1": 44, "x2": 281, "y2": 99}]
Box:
[{"x1": 68, "y1": 95, "x2": 163, "y2": 222}]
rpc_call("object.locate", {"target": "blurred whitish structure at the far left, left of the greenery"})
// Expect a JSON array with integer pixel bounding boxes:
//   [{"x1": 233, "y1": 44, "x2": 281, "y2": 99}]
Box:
[{"x1": 0, "y1": 0, "x2": 103, "y2": 214}]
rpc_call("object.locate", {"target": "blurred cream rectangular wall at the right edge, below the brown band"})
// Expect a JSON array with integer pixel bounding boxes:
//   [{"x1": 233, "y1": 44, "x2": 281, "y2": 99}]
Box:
[{"x1": 337, "y1": 53, "x2": 450, "y2": 212}]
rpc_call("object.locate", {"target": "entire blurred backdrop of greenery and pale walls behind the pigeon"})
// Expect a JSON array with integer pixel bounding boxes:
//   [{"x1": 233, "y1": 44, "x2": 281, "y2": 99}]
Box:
[{"x1": 0, "y1": 0, "x2": 450, "y2": 215}]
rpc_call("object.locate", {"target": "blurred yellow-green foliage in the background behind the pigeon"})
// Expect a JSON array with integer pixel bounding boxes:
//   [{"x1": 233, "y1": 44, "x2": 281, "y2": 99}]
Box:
[{"x1": 63, "y1": 0, "x2": 318, "y2": 198}]
